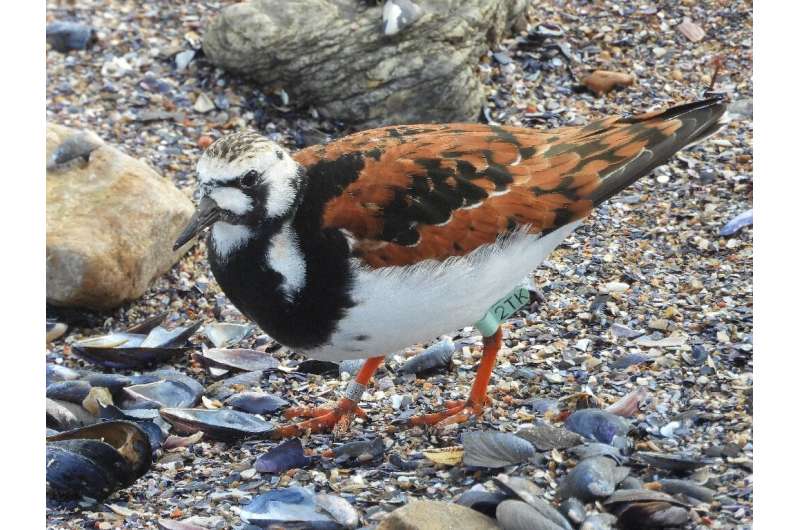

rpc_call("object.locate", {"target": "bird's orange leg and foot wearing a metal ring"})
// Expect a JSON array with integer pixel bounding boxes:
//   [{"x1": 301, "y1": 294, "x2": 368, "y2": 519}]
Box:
[{"x1": 272, "y1": 357, "x2": 383, "y2": 439}]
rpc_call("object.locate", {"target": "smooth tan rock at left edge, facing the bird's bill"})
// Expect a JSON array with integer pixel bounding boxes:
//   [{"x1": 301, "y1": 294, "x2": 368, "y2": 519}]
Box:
[{"x1": 46, "y1": 124, "x2": 193, "y2": 309}]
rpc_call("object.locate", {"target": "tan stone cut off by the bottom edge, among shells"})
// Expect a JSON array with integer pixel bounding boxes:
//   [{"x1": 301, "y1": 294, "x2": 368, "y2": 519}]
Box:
[{"x1": 377, "y1": 501, "x2": 500, "y2": 530}]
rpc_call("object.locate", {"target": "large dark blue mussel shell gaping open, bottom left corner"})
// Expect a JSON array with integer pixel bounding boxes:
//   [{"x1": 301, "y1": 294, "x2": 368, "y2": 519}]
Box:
[{"x1": 47, "y1": 421, "x2": 152, "y2": 499}]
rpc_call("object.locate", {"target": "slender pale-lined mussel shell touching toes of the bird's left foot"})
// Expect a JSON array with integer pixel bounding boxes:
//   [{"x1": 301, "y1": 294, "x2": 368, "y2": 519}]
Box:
[{"x1": 160, "y1": 408, "x2": 272, "y2": 441}]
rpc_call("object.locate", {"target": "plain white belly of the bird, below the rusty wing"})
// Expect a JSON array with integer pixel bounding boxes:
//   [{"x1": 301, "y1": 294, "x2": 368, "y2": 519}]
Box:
[{"x1": 302, "y1": 221, "x2": 580, "y2": 360}]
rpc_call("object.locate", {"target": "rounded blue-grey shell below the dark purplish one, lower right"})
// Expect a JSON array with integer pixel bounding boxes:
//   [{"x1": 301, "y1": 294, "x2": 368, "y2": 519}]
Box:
[{"x1": 558, "y1": 456, "x2": 630, "y2": 502}]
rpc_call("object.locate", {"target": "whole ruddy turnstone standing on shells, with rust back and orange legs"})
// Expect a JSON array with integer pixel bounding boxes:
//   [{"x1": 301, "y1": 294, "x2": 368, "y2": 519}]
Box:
[{"x1": 175, "y1": 97, "x2": 725, "y2": 437}]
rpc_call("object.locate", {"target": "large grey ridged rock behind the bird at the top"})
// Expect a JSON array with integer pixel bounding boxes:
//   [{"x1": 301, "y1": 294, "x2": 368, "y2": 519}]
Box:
[{"x1": 203, "y1": 0, "x2": 530, "y2": 127}]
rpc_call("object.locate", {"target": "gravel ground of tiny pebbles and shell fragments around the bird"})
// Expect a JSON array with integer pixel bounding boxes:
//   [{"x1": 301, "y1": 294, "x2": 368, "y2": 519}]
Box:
[{"x1": 47, "y1": 0, "x2": 753, "y2": 528}]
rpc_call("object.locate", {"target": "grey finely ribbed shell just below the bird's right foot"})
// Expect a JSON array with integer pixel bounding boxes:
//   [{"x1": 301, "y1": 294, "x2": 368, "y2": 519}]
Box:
[{"x1": 463, "y1": 431, "x2": 535, "y2": 468}]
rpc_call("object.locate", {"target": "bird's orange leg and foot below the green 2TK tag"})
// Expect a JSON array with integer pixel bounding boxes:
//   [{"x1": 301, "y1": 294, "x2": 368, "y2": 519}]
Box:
[{"x1": 408, "y1": 329, "x2": 503, "y2": 426}]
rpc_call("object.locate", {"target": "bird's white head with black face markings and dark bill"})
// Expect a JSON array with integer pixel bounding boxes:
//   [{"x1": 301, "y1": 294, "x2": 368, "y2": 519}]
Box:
[{"x1": 174, "y1": 132, "x2": 303, "y2": 250}]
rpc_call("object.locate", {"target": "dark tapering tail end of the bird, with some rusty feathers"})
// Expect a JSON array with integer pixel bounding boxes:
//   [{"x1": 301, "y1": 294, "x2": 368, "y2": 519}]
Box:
[{"x1": 587, "y1": 96, "x2": 727, "y2": 206}]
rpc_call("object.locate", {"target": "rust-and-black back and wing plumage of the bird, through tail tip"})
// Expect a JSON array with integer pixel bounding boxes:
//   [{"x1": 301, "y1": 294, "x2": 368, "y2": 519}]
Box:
[{"x1": 295, "y1": 98, "x2": 725, "y2": 267}]
